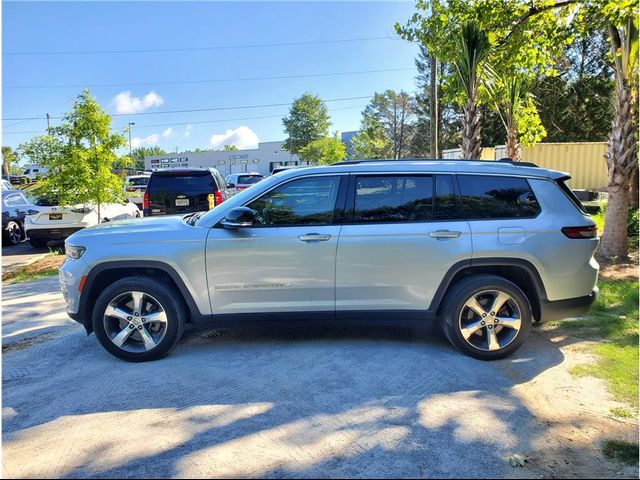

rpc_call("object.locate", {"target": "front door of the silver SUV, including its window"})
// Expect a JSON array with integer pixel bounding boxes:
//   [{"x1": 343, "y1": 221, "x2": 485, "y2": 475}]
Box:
[{"x1": 206, "y1": 175, "x2": 347, "y2": 314}]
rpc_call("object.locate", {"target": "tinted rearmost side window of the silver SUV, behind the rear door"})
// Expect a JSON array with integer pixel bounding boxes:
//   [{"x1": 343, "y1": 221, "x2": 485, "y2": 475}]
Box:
[{"x1": 458, "y1": 175, "x2": 540, "y2": 219}]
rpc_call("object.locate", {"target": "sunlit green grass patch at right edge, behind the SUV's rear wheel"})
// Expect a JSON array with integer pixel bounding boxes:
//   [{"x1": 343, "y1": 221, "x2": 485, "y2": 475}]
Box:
[{"x1": 560, "y1": 280, "x2": 639, "y2": 410}]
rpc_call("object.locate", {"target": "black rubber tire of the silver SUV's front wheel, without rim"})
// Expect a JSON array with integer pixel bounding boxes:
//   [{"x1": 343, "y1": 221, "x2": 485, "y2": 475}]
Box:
[{"x1": 92, "y1": 277, "x2": 187, "y2": 362}]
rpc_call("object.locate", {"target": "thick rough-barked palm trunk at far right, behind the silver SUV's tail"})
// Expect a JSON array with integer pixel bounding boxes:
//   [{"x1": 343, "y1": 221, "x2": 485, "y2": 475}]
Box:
[{"x1": 599, "y1": 15, "x2": 638, "y2": 257}]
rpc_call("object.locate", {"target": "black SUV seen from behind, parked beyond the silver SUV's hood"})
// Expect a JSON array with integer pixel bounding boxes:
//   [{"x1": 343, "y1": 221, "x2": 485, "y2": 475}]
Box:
[{"x1": 143, "y1": 168, "x2": 229, "y2": 217}]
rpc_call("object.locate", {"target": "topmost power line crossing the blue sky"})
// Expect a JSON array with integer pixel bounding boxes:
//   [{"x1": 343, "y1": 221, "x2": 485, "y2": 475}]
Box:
[{"x1": 4, "y1": 36, "x2": 400, "y2": 56}]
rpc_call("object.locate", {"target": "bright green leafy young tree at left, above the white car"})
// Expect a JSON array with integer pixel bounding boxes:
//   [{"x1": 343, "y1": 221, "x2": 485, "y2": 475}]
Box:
[{"x1": 19, "y1": 90, "x2": 126, "y2": 213}]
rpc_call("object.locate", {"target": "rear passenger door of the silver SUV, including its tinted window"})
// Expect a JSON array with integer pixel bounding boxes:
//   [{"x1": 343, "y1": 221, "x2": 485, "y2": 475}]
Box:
[{"x1": 336, "y1": 173, "x2": 471, "y2": 318}]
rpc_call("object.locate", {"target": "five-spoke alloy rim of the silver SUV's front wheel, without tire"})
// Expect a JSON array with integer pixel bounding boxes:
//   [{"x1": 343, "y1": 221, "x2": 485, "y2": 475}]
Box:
[{"x1": 103, "y1": 292, "x2": 167, "y2": 353}]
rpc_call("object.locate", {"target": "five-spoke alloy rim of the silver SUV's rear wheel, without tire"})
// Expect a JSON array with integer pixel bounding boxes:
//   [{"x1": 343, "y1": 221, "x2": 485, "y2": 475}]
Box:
[{"x1": 459, "y1": 290, "x2": 522, "y2": 352}]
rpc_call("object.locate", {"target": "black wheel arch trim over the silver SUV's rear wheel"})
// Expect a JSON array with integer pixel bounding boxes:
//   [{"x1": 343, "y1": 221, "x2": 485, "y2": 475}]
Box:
[{"x1": 429, "y1": 257, "x2": 547, "y2": 321}]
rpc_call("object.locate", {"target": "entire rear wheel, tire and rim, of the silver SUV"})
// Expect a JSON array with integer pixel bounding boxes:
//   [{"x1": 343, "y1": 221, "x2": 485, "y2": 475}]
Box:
[{"x1": 442, "y1": 275, "x2": 532, "y2": 360}]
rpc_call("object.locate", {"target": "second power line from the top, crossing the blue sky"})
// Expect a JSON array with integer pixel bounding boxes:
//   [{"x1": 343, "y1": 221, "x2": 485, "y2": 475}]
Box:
[{"x1": 3, "y1": 67, "x2": 415, "y2": 89}]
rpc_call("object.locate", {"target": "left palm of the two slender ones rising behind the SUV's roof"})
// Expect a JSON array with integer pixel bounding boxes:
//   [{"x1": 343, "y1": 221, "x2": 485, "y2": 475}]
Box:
[{"x1": 453, "y1": 21, "x2": 492, "y2": 158}]
